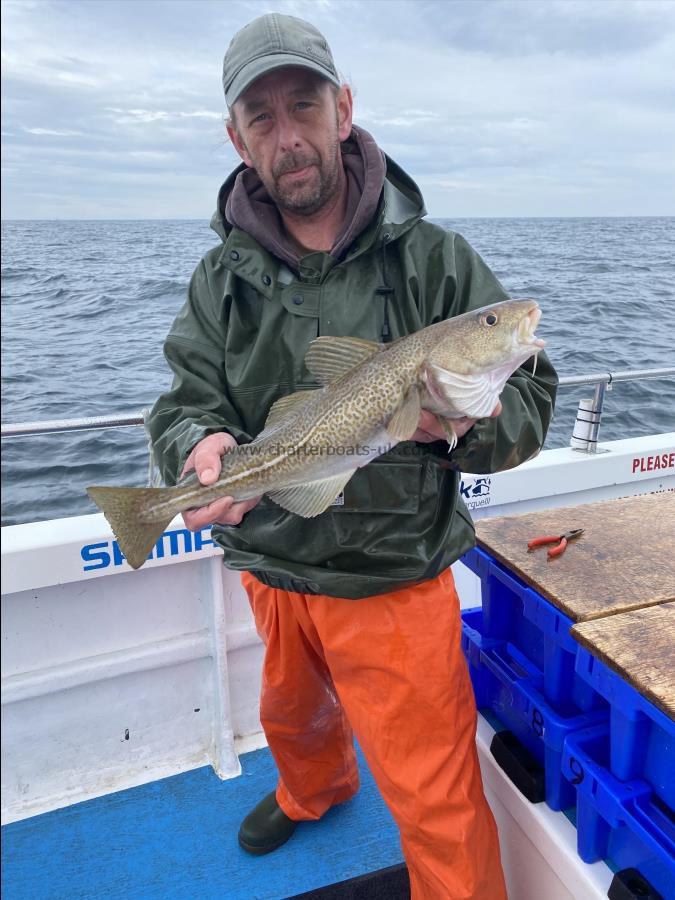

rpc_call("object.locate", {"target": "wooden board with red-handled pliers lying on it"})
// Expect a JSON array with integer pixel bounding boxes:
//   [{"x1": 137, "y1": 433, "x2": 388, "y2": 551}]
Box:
[{"x1": 476, "y1": 491, "x2": 675, "y2": 622}]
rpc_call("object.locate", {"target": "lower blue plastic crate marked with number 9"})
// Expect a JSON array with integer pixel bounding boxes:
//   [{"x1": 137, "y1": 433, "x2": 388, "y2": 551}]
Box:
[{"x1": 563, "y1": 722, "x2": 675, "y2": 898}]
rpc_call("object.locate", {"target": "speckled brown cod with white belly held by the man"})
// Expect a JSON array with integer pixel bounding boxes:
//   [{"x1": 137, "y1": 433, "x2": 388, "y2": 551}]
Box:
[{"x1": 87, "y1": 300, "x2": 545, "y2": 569}]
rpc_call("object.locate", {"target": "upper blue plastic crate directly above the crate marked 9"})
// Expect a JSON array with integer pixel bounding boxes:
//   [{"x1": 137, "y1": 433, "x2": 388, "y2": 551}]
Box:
[{"x1": 576, "y1": 646, "x2": 675, "y2": 810}]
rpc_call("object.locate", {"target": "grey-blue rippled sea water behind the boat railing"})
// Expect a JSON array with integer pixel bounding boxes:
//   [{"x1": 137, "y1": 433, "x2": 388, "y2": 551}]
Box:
[{"x1": 2, "y1": 217, "x2": 675, "y2": 525}]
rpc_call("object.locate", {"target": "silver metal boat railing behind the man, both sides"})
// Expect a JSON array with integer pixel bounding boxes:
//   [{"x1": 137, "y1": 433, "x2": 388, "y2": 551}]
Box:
[{"x1": 1, "y1": 366, "x2": 675, "y2": 453}]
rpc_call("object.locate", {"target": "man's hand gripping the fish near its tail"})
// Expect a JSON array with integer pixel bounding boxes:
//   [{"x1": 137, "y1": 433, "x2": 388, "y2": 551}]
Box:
[{"x1": 180, "y1": 432, "x2": 261, "y2": 531}]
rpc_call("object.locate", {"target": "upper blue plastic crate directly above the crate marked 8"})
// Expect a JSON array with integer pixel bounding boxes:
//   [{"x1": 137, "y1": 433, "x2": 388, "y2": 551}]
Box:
[{"x1": 462, "y1": 547, "x2": 607, "y2": 715}]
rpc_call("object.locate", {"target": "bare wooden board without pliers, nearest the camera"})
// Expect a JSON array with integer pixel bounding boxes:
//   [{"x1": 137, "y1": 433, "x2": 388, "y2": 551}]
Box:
[{"x1": 571, "y1": 603, "x2": 675, "y2": 719}]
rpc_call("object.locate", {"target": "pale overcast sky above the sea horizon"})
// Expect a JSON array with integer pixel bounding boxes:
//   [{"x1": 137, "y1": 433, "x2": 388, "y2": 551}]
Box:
[{"x1": 2, "y1": 0, "x2": 675, "y2": 219}]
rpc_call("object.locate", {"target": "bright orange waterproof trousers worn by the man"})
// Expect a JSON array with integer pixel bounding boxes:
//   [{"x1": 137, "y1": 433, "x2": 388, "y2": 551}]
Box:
[{"x1": 242, "y1": 569, "x2": 506, "y2": 900}]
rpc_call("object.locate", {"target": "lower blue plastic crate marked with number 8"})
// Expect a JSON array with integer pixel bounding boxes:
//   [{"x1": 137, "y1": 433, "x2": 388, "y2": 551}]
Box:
[{"x1": 462, "y1": 608, "x2": 607, "y2": 810}]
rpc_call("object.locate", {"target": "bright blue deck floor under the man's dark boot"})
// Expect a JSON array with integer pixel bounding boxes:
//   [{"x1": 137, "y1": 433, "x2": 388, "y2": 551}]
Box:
[{"x1": 2, "y1": 749, "x2": 402, "y2": 900}]
